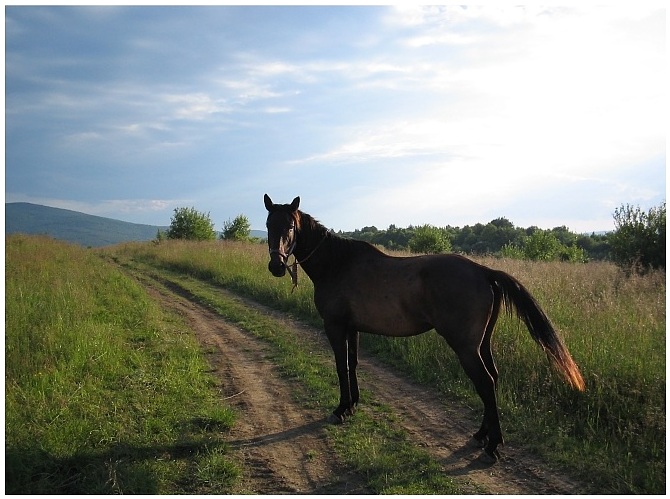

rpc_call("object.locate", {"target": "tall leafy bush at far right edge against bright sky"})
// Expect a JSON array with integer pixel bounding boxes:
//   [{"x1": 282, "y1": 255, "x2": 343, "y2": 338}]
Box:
[{"x1": 610, "y1": 201, "x2": 665, "y2": 271}]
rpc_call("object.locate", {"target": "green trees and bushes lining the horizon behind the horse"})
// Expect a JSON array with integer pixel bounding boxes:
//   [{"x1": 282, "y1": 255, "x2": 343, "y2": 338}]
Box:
[{"x1": 157, "y1": 201, "x2": 665, "y2": 272}]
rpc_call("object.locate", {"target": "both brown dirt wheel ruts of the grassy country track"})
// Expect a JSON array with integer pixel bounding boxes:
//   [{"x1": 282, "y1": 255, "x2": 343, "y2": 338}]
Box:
[{"x1": 133, "y1": 278, "x2": 586, "y2": 494}]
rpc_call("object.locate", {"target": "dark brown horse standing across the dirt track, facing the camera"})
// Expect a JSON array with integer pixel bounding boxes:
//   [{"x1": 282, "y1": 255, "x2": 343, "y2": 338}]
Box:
[{"x1": 265, "y1": 194, "x2": 584, "y2": 462}]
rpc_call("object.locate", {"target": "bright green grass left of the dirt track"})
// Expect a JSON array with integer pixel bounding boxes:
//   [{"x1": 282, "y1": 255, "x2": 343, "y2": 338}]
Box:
[{"x1": 5, "y1": 235, "x2": 239, "y2": 494}]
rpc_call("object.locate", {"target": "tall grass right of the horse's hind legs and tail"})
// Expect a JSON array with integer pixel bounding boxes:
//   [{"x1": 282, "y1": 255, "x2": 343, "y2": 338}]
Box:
[{"x1": 488, "y1": 262, "x2": 666, "y2": 493}]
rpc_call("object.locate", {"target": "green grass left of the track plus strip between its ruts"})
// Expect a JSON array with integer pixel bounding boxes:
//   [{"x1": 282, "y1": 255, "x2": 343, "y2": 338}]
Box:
[{"x1": 5, "y1": 235, "x2": 462, "y2": 494}]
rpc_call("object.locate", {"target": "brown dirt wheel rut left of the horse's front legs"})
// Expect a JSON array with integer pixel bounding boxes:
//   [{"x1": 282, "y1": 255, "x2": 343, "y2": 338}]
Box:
[{"x1": 143, "y1": 280, "x2": 370, "y2": 494}]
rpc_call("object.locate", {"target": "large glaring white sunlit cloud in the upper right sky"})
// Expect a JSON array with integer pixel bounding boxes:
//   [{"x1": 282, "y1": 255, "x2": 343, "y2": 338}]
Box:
[{"x1": 295, "y1": 7, "x2": 665, "y2": 181}]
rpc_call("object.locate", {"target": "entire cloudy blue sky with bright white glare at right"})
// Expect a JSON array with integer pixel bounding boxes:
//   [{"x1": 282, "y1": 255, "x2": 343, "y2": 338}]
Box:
[{"x1": 5, "y1": 2, "x2": 667, "y2": 232}]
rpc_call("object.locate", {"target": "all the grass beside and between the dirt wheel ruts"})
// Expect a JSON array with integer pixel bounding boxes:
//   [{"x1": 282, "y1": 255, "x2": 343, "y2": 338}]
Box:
[{"x1": 5, "y1": 236, "x2": 665, "y2": 494}]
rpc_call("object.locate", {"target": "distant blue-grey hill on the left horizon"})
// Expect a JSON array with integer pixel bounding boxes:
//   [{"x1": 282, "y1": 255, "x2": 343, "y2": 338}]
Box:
[{"x1": 5, "y1": 203, "x2": 167, "y2": 247}]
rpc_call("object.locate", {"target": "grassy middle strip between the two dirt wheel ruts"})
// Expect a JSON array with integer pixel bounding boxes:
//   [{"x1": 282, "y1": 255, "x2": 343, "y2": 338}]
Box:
[{"x1": 116, "y1": 255, "x2": 461, "y2": 494}]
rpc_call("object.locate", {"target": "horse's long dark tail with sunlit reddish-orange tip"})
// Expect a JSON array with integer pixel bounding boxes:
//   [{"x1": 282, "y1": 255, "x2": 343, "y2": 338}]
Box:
[{"x1": 491, "y1": 270, "x2": 585, "y2": 392}]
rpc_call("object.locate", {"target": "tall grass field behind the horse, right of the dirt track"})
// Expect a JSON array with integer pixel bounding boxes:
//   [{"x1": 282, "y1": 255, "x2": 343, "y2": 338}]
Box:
[{"x1": 107, "y1": 241, "x2": 665, "y2": 493}]
